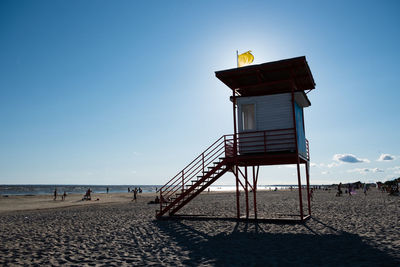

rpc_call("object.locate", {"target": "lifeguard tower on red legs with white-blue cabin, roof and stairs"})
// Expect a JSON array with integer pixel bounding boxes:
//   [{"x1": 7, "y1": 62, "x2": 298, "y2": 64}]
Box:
[{"x1": 156, "y1": 57, "x2": 315, "y2": 221}]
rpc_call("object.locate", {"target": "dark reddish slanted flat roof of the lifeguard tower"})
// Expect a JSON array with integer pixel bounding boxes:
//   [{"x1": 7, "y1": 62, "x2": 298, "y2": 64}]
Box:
[{"x1": 215, "y1": 56, "x2": 315, "y2": 96}]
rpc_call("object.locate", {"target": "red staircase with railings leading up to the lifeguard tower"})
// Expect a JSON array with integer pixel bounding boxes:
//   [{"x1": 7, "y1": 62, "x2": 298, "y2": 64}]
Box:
[{"x1": 156, "y1": 135, "x2": 234, "y2": 218}]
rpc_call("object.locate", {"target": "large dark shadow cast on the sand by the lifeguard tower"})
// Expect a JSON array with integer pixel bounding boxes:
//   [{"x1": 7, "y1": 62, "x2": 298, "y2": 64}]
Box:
[{"x1": 154, "y1": 219, "x2": 399, "y2": 266}]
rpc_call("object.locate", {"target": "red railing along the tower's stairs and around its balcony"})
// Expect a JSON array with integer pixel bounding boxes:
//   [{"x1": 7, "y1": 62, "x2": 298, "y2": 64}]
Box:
[{"x1": 157, "y1": 128, "x2": 309, "y2": 219}]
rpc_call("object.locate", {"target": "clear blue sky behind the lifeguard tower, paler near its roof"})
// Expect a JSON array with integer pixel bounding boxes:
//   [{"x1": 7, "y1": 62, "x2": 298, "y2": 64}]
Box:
[{"x1": 0, "y1": 1, "x2": 400, "y2": 184}]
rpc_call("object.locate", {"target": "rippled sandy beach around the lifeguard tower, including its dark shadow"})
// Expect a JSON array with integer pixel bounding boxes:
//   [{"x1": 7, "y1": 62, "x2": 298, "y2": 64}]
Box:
[{"x1": 0, "y1": 189, "x2": 400, "y2": 266}]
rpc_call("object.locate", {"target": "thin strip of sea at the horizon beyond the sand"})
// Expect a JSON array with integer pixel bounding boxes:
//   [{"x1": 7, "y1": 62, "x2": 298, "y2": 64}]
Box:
[{"x1": 0, "y1": 184, "x2": 310, "y2": 196}]
